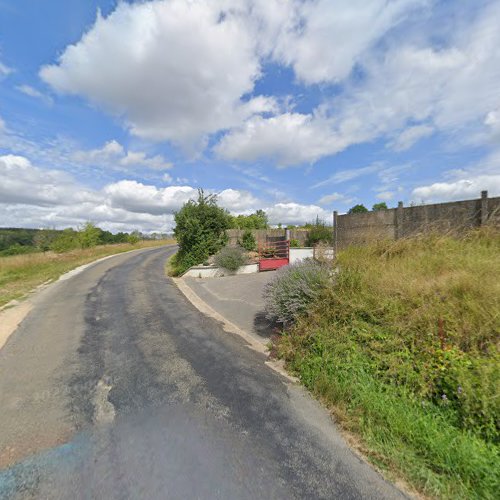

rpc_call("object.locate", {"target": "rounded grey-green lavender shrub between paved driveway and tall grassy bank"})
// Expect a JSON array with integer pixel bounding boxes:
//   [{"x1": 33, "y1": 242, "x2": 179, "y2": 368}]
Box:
[{"x1": 264, "y1": 259, "x2": 331, "y2": 325}]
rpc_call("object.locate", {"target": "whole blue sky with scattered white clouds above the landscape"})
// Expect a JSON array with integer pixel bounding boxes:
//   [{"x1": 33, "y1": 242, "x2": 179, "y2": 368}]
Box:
[{"x1": 0, "y1": 0, "x2": 500, "y2": 232}]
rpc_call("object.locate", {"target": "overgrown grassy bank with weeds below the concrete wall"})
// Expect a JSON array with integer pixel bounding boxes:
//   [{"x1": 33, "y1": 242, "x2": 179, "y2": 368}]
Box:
[{"x1": 277, "y1": 229, "x2": 500, "y2": 499}]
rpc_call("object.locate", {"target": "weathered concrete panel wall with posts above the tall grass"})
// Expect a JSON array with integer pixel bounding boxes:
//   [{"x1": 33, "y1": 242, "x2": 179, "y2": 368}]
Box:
[{"x1": 334, "y1": 191, "x2": 500, "y2": 249}]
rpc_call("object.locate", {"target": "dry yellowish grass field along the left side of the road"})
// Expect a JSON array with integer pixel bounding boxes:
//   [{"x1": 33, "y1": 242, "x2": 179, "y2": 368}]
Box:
[{"x1": 0, "y1": 240, "x2": 174, "y2": 306}]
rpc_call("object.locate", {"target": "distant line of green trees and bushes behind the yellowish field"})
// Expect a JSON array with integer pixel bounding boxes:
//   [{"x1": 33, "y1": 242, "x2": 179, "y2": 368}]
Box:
[{"x1": 0, "y1": 222, "x2": 158, "y2": 256}]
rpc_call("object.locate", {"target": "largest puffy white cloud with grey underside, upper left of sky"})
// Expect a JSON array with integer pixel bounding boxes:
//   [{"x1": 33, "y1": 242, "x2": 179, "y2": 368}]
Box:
[{"x1": 40, "y1": 0, "x2": 275, "y2": 148}]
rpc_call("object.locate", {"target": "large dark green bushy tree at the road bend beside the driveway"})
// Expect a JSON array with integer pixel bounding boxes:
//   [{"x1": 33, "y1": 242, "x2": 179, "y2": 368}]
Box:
[{"x1": 174, "y1": 189, "x2": 230, "y2": 273}]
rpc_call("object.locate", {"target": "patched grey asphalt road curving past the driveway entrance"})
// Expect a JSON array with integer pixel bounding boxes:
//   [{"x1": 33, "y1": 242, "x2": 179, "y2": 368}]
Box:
[{"x1": 0, "y1": 248, "x2": 402, "y2": 499}]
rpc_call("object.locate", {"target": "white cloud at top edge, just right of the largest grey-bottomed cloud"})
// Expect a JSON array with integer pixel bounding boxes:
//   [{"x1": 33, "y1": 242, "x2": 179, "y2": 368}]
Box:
[{"x1": 274, "y1": 0, "x2": 429, "y2": 84}]
